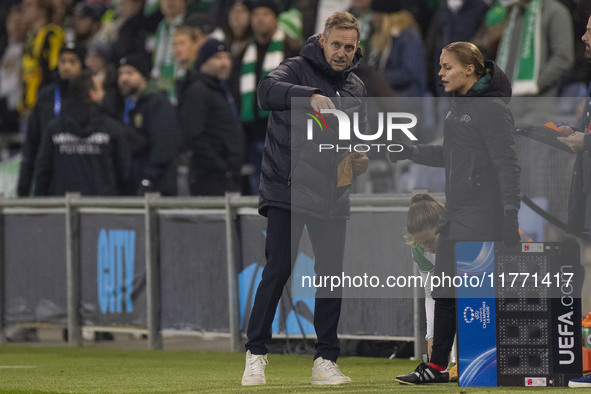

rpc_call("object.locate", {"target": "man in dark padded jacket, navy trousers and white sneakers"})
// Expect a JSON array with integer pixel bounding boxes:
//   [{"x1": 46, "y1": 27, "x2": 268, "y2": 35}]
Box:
[{"x1": 242, "y1": 12, "x2": 367, "y2": 385}]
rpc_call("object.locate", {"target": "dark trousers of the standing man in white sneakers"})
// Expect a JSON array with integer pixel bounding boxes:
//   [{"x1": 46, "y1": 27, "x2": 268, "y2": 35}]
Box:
[{"x1": 246, "y1": 207, "x2": 347, "y2": 361}]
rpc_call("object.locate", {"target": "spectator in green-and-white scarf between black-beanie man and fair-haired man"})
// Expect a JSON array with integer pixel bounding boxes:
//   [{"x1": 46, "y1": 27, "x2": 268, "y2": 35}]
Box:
[{"x1": 151, "y1": 0, "x2": 187, "y2": 103}]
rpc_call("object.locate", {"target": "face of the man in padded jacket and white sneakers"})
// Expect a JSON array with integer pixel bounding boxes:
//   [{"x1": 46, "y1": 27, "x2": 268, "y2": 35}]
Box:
[{"x1": 319, "y1": 28, "x2": 359, "y2": 71}]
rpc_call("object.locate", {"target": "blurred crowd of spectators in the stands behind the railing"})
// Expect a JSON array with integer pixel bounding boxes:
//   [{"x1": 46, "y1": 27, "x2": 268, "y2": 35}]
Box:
[{"x1": 0, "y1": 0, "x2": 591, "y2": 196}]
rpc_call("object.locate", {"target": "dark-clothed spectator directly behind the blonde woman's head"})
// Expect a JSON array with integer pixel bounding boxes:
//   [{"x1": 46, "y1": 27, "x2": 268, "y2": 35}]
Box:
[{"x1": 426, "y1": 0, "x2": 488, "y2": 96}]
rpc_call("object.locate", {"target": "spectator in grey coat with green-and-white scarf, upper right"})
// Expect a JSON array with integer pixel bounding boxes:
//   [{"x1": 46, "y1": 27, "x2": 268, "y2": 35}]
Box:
[{"x1": 497, "y1": 0, "x2": 574, "y2": 97}]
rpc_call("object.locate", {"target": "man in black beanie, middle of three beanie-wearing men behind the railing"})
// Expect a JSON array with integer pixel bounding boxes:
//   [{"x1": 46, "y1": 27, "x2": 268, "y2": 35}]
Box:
[{"x1": 116, "y1": 54, "x2": 180, "y2": 195}]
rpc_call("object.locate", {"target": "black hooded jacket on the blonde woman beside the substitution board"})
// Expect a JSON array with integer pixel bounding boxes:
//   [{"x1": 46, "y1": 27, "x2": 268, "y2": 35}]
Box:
[{"x1": 412, "y1": 62, "x2": 521, "y2": 241}]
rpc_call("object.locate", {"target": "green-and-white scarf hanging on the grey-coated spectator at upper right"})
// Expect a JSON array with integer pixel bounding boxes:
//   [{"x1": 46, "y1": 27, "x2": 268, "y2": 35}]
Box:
[{"x1": 497, "y1": 0, "x2": 542, "y2": 96}]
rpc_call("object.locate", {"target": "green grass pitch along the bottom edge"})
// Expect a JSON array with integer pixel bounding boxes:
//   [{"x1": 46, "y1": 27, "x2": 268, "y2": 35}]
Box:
[{"x1": 0, "y1": 345, "x2": 586, "y2": 393}]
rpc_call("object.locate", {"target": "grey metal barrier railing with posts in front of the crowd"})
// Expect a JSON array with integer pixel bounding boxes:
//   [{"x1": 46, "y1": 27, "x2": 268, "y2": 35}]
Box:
[{"x1": 0, "y1": 193, "x2": 444, "y2": 351}]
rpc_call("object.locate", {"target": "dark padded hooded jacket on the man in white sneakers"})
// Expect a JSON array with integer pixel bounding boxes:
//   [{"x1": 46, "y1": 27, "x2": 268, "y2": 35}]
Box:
[{"x1": 257, "y1": 36, "x2": 366, "y2": 220}]
